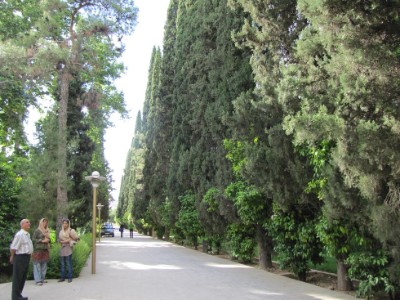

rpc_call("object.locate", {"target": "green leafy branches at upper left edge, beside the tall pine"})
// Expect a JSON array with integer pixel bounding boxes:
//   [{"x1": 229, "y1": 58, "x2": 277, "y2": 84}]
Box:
[{"x1": 0, "y1": 0, "x2": 42, "y2": 155}]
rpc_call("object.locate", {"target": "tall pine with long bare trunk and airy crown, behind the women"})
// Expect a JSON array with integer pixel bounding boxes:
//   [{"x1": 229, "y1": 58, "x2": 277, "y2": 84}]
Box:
[{"x1": 13, "y1": 0, "x2": 136, "y2": 227}]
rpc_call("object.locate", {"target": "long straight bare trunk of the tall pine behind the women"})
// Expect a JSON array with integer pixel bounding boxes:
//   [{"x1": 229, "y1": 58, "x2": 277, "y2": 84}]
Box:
[{"x1": 57, "y1": 67, "x2": 70, "y2": 228}]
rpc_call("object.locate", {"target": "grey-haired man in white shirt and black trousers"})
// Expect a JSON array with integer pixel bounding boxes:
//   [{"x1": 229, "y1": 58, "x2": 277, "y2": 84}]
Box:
[{"x1": 10, "y1": 219, "x2": 33, "y2": 300}]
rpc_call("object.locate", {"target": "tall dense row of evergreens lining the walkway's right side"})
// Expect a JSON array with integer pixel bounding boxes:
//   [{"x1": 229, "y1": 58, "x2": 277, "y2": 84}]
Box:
[{"x1": 117, "y1": 0, "x2": 400, "y2": 299}]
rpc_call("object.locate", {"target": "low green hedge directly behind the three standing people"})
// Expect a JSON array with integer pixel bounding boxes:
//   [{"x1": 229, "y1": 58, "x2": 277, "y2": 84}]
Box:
[{"x1": 28, "y1": 233, "x2": 92, "y2": 279}]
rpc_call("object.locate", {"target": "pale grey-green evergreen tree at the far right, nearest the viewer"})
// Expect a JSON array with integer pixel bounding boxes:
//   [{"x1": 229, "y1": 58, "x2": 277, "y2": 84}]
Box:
[{"x1": 281, "y1": 1, "x2": 400, "y2": 297}]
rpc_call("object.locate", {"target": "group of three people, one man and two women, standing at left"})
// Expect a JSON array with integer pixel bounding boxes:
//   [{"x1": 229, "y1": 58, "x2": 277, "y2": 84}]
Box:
[{"x1": 10, "y1": 218, "x2": 79, "y2": 300}]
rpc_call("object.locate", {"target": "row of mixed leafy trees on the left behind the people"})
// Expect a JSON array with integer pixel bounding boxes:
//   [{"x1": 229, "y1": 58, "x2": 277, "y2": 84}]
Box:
[{"x1": 0, "y1": 0, "x2": 137, "y2": 273}]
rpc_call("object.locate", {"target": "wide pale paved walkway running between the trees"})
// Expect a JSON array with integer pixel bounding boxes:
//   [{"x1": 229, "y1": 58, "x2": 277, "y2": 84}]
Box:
[{"x1": 0, "y1": 231, "x2": 355, "y2": 300}]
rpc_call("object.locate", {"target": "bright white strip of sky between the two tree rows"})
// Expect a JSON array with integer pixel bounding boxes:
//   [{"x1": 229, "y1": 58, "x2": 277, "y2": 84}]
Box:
[{"x1": 105, "y1": 0, "x2": 170, "y2": 207}]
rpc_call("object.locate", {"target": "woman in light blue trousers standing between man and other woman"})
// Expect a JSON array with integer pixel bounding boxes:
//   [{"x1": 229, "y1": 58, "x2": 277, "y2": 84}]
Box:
[{"x1": 32, "y1": 218, "x2": 50, "y2": 286}]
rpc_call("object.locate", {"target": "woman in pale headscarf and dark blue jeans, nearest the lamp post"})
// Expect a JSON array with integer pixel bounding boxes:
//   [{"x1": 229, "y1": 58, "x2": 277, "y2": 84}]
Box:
[{"x1": 58, "y1": 219, "x2": 79, "y2": 282}]
